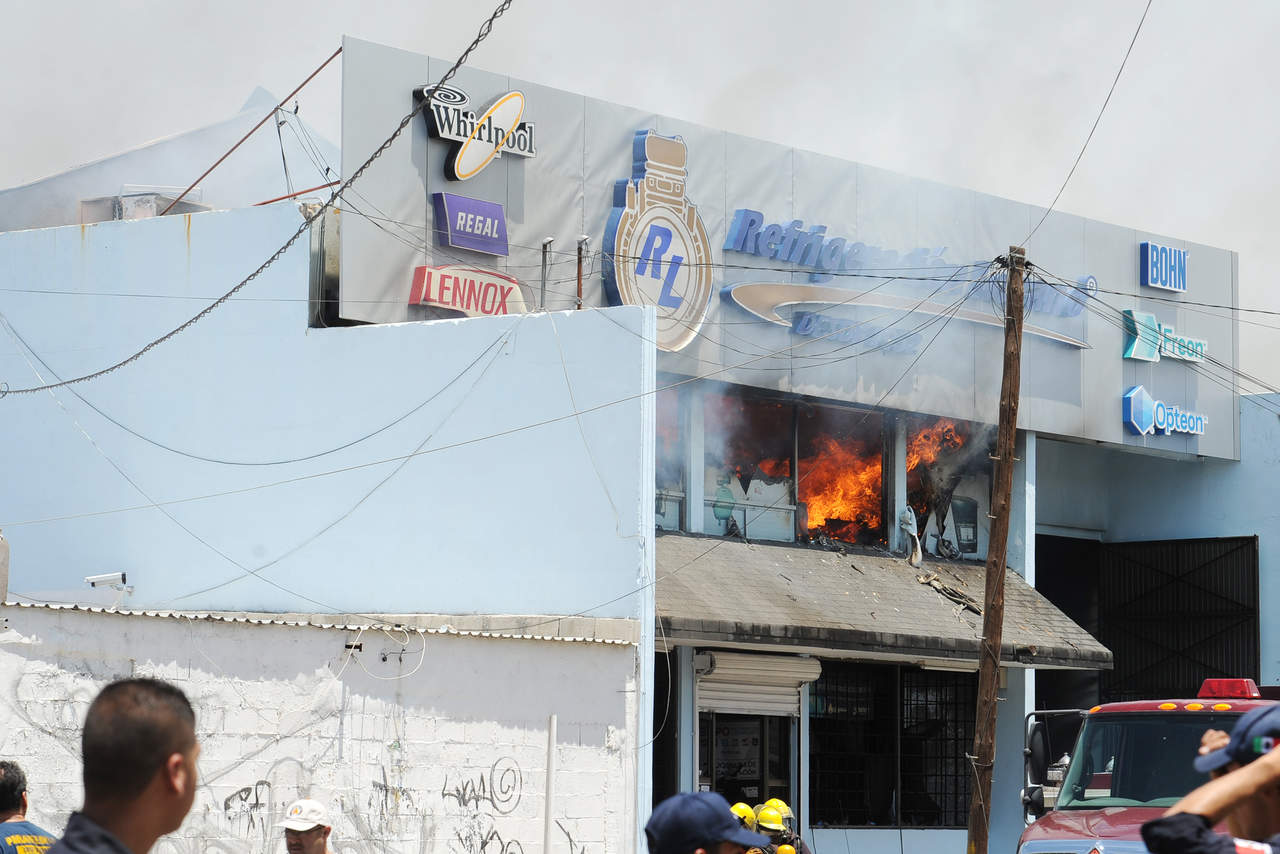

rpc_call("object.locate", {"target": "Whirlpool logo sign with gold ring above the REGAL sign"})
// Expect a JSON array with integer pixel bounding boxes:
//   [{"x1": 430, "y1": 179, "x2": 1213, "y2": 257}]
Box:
[{"x1": 413, "y1": 86, "x2": 538, "y2": 181}]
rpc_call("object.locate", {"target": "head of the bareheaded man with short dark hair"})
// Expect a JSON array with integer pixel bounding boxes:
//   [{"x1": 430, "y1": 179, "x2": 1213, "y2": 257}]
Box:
[{"x1": 81, "y1": 679, "x2": 200, "y2": 834}]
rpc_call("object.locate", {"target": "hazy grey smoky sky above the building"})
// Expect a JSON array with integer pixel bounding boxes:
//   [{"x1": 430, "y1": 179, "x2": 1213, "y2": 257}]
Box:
[{"x1": 0, "y1": 0, "x2": 1280, "y2": 381}]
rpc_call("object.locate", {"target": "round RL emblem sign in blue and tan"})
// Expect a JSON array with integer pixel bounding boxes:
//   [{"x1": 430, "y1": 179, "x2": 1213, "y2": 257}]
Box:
[{"x1": 604, "y1": 131, "x2": 712, "y2": 351}]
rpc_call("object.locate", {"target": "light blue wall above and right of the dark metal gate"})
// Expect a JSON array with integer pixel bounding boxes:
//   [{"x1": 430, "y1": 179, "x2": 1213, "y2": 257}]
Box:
[{"x1": 1038, "y1": 394, "x2": 1280, "y2": 684}]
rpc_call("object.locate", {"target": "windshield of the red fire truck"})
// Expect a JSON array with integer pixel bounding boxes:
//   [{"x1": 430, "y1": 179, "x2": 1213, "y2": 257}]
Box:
[{"x1": 1057, "y1": 712, "x2": 1239, "y2": 809}]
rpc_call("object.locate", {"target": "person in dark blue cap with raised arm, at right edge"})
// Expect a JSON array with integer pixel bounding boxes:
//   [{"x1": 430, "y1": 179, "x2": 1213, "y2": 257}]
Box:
[{"x1": 1142, "y1": 705, "x2": 1280, "y2": 854}]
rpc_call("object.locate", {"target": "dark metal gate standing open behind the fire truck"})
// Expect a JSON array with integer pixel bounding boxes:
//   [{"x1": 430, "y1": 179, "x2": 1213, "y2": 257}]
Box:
[{"x1": 1098, "y1": 536, "x2": 1260, "y2": 703}]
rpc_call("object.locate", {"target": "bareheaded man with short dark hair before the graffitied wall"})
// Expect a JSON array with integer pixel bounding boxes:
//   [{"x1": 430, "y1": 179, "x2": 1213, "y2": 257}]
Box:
[{"x1": 47, "y1": 679, "x2": 200, "y2": 854}]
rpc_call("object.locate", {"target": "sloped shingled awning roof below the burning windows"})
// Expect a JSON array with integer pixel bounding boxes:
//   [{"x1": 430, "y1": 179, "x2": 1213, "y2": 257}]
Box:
[{"x1": 657, "y1": 534, "x2": 1111, "y2": 670}]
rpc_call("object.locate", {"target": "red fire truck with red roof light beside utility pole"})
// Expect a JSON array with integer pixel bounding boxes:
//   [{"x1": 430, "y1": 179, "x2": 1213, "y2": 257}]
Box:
[{"x1": 1018, "y1": 679, "x2": 1280, "y2": 854}]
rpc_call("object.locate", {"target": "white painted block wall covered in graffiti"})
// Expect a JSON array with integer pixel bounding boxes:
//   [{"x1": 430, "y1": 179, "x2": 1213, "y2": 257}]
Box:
[{"x1": 0, "y1": 607, "x2": 648, "y2": 854}]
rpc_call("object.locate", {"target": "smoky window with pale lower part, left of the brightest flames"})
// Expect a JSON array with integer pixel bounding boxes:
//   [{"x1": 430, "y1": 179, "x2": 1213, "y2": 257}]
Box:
[{"x1": 703, "y1": 391, "x2": 795, "y2": 540}]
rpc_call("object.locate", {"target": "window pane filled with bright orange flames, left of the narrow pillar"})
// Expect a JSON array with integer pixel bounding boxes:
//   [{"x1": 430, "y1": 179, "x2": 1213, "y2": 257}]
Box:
[{"x1": 797, "y1": 406, "x2": 884, "y2": 543}]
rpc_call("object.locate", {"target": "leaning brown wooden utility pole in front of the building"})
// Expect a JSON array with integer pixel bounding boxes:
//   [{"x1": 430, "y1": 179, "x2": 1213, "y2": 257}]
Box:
[{"x1": 968, "y1": 246, "x2": 1027, "y2": 854}]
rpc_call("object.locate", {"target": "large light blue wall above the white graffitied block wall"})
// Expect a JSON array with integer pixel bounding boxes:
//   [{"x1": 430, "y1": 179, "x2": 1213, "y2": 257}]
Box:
[{"x1": 0, "y1": 204, "x2": 654, "y2": 626}]
